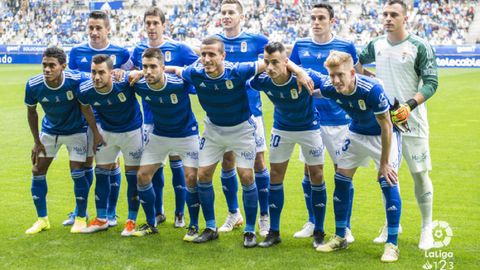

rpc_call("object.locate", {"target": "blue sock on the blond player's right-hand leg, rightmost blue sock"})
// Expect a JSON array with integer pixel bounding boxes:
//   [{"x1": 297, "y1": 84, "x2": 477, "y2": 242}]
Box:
[{"x1": 378, "y1": 177, "x2": 402, "y2": 245}]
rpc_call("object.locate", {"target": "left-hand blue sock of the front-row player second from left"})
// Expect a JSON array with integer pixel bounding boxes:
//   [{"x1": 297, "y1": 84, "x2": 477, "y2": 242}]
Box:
[{"x1": 95, "y1": 167, "x2": 111, "y2": 219}]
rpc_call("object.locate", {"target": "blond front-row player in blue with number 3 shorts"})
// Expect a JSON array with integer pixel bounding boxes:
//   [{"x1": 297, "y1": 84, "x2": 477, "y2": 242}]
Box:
[{"x1": 317, "y1": 51, "x2": 402, "y2": 262}]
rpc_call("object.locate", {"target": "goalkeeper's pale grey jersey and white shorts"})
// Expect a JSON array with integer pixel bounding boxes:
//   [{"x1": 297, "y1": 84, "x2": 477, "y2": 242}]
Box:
[{"x1": 359, "y1": 34, "x2": 438, "y2": 138}]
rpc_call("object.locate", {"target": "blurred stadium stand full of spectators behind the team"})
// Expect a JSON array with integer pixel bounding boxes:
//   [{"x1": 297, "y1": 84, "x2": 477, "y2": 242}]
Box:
[{"x1": 0, "y1": 0, "x2": 480, "y2": 46}]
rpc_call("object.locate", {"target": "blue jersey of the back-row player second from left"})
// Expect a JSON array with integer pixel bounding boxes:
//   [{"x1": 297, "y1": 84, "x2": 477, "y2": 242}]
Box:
[{"x1": 130, "y1": 41, "x2": 198, "y2": 124}]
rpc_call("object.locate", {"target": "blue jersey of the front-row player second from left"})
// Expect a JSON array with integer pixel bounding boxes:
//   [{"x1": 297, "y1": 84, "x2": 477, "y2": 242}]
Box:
[{"x1": 78, "y1": 75, "x2": 142, "y2": 133}]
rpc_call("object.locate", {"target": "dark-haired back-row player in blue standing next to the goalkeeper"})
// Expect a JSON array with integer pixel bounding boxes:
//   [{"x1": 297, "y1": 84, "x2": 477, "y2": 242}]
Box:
[{"x1": 290, "y1": 3, "x2": 358, "y2": 243}]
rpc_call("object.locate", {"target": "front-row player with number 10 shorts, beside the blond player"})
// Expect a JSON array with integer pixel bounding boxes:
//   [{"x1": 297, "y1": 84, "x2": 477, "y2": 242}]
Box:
[{"x1": 250, "y1": 42, "x2": 325, "y2": 248}]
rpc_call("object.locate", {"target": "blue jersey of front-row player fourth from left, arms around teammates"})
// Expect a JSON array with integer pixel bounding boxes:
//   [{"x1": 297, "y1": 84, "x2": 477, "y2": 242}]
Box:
[{"x1": 182, "y1": 62, "x2": 257, "y2": 126}]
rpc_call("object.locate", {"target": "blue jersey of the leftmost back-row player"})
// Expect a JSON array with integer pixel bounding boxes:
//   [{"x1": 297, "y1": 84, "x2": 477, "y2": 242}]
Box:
[{"x1": 68, "y1": 42, "x2": 131, "y2": 72}]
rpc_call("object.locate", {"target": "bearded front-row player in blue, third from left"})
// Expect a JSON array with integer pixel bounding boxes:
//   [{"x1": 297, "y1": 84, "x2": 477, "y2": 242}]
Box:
[{"x1": 130, "y1": 48, "x2": 200, "y2": 238}]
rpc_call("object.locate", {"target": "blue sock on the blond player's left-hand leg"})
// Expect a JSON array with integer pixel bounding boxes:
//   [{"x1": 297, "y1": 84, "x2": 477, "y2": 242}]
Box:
[{"x1": 333, "y1": 173, "x2": 352, "y2": 237}]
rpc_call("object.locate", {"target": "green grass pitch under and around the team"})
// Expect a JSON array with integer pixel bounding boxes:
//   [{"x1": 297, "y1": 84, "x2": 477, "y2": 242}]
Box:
[{"x1": 0, "y1": 65, "x2": 480, "y2": 269}]
